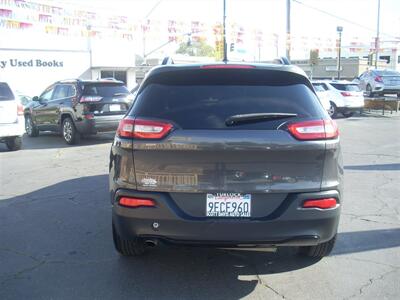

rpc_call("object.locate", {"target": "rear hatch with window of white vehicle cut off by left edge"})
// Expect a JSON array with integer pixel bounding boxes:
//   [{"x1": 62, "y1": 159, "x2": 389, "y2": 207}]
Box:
[{"x1": 0, "y1": 82, "x2": 18, "y2": 124}]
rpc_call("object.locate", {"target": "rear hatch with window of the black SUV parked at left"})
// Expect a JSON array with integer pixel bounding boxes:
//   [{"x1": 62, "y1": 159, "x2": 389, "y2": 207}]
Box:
[{"x1": 80, "y1": 81, "x2": 132, "y2": 116}]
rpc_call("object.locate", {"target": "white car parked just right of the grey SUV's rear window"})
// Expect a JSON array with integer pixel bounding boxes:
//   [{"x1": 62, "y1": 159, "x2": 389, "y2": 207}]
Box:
[{"x1": 321, "y1": 80, "x2": 364, "y2": 117}]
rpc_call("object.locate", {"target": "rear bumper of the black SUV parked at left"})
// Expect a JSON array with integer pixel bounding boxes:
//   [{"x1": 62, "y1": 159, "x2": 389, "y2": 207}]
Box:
[{"x1": 75, "y1": 114, "x2": 124, "y2": 134}]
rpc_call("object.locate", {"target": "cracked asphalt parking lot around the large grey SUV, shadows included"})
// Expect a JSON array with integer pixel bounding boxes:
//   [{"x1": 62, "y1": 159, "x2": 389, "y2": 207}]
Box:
[{"x1": 0, "y1": 113, "x2": 400, "y2": 299}]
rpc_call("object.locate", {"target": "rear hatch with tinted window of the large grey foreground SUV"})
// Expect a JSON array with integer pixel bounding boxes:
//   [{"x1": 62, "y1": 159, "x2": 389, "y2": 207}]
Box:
[{"x1": 126, "y1": 68, "x2": 332, "y2": 217}]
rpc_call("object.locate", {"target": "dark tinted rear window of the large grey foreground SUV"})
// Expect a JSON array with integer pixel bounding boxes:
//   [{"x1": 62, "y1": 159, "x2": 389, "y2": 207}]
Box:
[{"x1": 131, "y1": 71, "x2": 322, "y2": 129}]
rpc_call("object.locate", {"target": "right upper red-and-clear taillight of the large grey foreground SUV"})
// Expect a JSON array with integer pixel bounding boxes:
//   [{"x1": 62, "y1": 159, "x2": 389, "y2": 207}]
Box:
[{"x1": 288, "y1": 120, "x2": 339, "y2": 141}]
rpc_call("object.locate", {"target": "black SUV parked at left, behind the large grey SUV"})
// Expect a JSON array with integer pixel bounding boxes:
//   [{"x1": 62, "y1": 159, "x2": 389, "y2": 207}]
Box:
[{"x1": 24, "y1": 79, "x2": 132, "y2": 144}]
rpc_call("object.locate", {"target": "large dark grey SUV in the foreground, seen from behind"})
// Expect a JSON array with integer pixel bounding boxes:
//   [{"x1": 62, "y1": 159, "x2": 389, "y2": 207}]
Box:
[{"x1": 110, "y1": 64, "x2": 343, "y2": 257}]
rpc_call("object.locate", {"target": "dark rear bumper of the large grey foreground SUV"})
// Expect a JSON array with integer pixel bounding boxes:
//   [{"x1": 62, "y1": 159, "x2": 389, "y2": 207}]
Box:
[{"x1": 113, "y1": 190, "x2": 340, "y2": 246}]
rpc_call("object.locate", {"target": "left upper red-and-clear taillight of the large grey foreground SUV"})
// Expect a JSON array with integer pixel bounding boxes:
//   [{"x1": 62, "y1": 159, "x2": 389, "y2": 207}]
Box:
[{"x1": 117, "y1": 119, "x2": 173, "y2": 139}]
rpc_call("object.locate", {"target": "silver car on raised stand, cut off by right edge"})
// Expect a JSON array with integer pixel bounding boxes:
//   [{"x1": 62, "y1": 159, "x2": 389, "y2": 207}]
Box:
[{"x1": 354, "y1": 70, "x2": 400, "y2": 98}]
